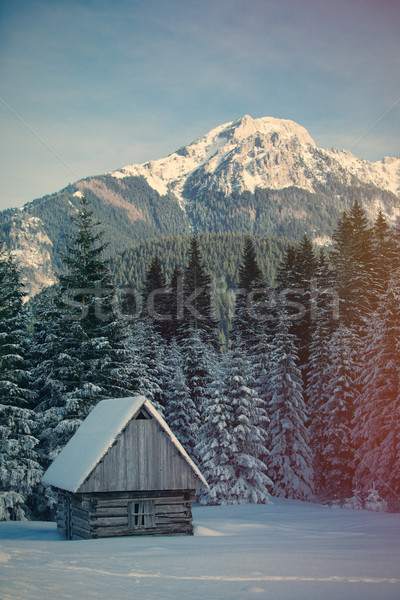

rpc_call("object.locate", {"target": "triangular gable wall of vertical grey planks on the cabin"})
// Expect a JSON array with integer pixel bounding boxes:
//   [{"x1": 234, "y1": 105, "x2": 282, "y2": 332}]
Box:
[{"x1": 78, "y1": 419, "x2": 204, "y2": 493}]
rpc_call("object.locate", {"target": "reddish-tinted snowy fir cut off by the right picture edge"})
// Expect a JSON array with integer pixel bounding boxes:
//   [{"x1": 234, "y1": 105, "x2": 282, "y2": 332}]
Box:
[{"x1": 354, "y1": 270, "x2": 400, "y2": 509}]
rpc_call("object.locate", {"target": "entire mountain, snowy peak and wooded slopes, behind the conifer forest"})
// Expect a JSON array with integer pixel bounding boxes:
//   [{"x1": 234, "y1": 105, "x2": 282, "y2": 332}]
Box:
[{"x1": 0, "y1": 115, "x2": 400, "y2": 295}]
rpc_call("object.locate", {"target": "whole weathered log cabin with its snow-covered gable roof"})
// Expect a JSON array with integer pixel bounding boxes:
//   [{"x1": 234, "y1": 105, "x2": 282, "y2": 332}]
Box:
[{"x1": 43, "y1": 396, "x2": 207, "y2": 539}]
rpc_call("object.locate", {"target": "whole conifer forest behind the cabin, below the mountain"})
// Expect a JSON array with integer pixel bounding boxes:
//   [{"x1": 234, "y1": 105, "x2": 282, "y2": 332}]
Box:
[{"x1": 0, "y1": 197, "x2": 400, "y2": 520}]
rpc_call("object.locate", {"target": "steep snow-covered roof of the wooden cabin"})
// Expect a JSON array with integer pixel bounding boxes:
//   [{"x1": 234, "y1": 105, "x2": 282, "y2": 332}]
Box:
[{"x1": 42, "y1": 396, "x2": 208, "y2": 492}]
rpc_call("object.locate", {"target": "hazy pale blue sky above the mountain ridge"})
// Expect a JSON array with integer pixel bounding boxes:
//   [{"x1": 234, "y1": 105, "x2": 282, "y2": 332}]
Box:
[{"x1": 0, "y1": 0, "x2": 400, "y2": 208}]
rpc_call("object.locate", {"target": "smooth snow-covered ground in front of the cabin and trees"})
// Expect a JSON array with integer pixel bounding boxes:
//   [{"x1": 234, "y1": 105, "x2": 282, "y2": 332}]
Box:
[{"x1": 0, "y1": 499, "x2": 400, "y2": 600}]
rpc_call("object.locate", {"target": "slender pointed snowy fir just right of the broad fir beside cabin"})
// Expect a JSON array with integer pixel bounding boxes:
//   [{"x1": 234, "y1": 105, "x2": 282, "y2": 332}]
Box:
[{"x1": 267, "y1": 307, "x2": 314, "y2": 500}]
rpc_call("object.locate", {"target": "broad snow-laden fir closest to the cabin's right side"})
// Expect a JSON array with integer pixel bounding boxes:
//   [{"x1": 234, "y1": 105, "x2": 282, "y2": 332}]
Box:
[{"x1": 198, "y1": 340, "x2": 272, "y2": 504}]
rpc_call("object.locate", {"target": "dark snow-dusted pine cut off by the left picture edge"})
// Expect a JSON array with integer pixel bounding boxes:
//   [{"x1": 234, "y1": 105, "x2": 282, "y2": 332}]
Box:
[{"x1": 0, "y1": 254, "x2": 43, "y2": 521}]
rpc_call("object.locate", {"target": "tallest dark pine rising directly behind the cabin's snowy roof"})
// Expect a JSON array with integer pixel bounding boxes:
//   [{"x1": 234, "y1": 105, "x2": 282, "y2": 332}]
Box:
[{"x1": 35, "y1": 198, "x2": 134, "y2": 468}]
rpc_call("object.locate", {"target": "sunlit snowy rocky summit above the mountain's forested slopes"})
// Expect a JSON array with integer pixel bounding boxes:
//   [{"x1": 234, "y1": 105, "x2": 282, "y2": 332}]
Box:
[{"x1": 111, "y1": 115, "x2": 400, "y2": 211}]
